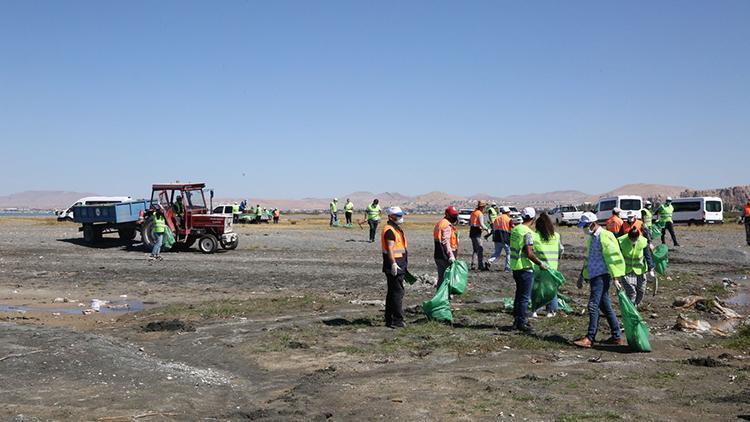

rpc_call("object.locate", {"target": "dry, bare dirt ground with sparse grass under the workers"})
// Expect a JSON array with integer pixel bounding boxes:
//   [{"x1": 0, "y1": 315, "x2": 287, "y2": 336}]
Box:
[{"x1": 0, "y1": 216, "x2": 750, "y2": 421}]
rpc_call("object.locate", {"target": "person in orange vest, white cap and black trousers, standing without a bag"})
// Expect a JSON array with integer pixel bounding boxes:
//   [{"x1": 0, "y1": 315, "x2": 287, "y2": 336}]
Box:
[{"x1": 381, "y1": 207, "x2": 409, "y2": 328}]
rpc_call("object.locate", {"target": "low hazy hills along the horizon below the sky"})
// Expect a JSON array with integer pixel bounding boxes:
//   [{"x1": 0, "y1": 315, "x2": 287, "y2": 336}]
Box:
[{"x1": 0, "y1": 184, "x2": 750, "y2": 212}]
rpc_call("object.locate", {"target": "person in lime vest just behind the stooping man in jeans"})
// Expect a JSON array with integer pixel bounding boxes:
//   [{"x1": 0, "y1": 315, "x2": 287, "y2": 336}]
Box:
[{"x1": 617, "y1": 226, "x2": 654, "y2": 306}]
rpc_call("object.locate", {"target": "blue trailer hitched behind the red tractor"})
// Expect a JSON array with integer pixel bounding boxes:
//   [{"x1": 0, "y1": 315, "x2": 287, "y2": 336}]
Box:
[{"x1": 73, "y1": 200, "x2": 151, "y2": 244}]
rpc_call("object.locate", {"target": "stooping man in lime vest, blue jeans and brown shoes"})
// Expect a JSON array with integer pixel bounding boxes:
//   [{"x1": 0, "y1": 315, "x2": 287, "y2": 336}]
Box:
[{"x1": 573, "y1": 212, "x2": 625, "y2": 348}]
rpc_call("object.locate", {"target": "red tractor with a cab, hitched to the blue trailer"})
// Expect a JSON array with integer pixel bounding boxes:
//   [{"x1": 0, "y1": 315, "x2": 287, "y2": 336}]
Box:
[{"x1": 141, "y1": 183, "x2": 239, "y2": 253}]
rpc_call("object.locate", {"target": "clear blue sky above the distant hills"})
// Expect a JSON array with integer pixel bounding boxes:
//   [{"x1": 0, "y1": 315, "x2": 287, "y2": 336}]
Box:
[{"x1": 0, "y1": 0, "x2": 750, "y2": 197}]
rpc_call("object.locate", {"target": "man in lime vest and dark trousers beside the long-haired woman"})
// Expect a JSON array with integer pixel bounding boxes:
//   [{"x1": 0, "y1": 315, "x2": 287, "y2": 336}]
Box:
[{"x1": 510, "y1": 207, "x2": 547, "y2": 333}]
